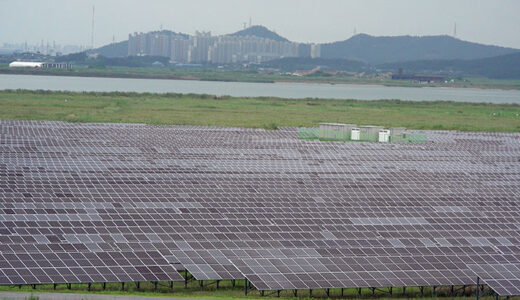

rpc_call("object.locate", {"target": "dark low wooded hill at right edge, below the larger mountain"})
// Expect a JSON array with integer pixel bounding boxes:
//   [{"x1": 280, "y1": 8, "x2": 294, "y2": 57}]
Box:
[{"x1": 377, "y1": 52, "x2": 520, "y2": 79}]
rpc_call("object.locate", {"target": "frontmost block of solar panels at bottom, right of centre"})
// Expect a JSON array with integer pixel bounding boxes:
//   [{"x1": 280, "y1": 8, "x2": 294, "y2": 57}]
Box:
[{"x1": 232, "y1": 256, "x2": 486, "y2": 290}]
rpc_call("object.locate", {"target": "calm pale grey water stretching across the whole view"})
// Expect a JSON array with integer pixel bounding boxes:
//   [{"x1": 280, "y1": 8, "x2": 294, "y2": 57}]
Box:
[{"x1": 0, "y1": 74, "x2": 520, "y2": 104}]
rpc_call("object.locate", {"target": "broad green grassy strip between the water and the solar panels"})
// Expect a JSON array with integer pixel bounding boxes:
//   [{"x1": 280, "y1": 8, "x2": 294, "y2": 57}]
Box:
[{"x1": 0, "y1": 91, "x2": 520, "y2": 132}]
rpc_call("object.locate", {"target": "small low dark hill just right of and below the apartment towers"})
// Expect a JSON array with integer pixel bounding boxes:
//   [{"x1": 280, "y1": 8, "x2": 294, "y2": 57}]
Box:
[{"x1": 262, "y1": 57, "x2": 370, "y2": 72}]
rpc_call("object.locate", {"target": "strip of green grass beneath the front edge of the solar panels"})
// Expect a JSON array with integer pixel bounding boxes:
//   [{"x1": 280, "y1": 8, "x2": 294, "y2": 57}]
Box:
[{"x1": 0, "y1": 280, "x2": 508, "y2": 300}]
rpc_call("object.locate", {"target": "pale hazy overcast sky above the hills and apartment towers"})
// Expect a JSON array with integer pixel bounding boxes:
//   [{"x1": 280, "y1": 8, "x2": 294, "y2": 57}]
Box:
[{"x1": 0, "y1": 0, "x2": 520, "y2": 48}]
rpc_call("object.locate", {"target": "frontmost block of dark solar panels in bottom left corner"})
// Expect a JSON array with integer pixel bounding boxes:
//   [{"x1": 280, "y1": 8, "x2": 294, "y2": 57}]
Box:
[{"x1": 0, "y1": 251, "x2": 183, "y2": 284}]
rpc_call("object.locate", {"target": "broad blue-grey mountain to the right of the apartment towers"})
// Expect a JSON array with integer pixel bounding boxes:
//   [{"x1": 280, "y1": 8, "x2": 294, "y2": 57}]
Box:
[{"x1": 321, "y1": 34, "x2": 520, "y2": 64}]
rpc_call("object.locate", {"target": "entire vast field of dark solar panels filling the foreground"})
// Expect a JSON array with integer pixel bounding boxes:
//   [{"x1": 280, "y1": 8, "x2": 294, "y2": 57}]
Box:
[{"x1": 0, "y1": 121, "x2": 520, "y2": 295}]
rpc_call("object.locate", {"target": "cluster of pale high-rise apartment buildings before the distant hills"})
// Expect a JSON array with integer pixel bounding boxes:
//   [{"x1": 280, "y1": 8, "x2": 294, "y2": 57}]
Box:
[{"x1": 128, "y1": 31, "x2": 319, "y2": 64}]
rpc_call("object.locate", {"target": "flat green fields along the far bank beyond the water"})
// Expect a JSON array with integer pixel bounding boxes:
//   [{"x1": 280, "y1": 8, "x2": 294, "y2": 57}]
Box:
[{"x1": 0, "y1": 65, "x2": 520, "y2": 89}]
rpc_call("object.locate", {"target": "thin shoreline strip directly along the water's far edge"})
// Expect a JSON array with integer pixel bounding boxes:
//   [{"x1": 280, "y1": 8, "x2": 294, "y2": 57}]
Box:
[{"x1": 0, "y1": 68, "x2": 520, "y2": 91}]
